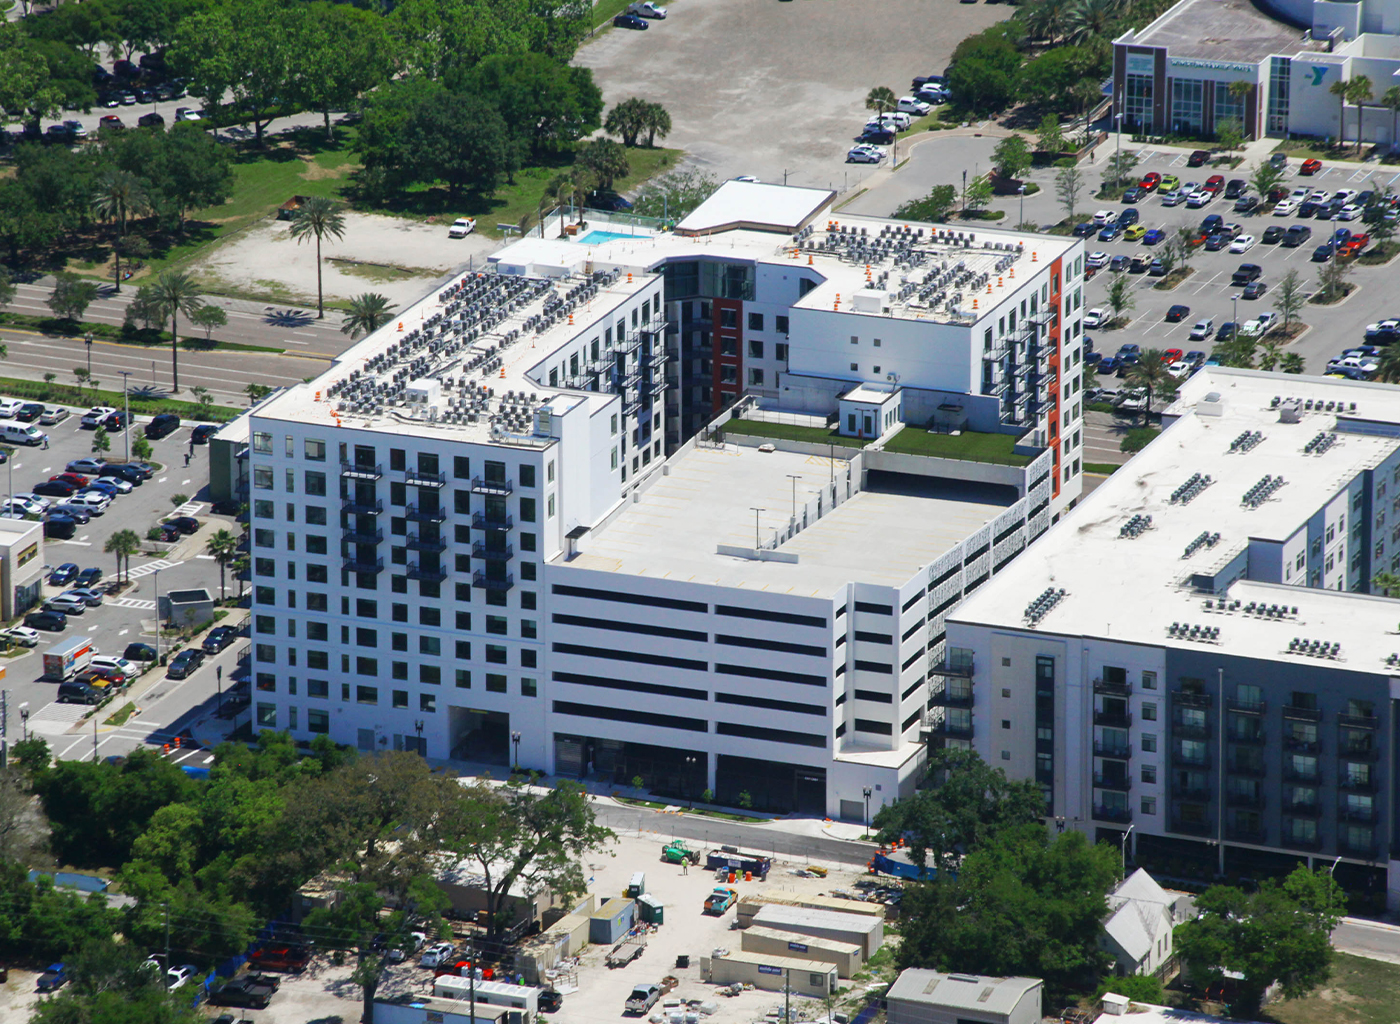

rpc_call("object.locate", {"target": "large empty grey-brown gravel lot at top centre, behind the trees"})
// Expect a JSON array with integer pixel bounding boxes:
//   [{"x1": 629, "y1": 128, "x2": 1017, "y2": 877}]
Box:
[{"x1": 577, "y1": 0, "x2": 1009, "y2": 188}]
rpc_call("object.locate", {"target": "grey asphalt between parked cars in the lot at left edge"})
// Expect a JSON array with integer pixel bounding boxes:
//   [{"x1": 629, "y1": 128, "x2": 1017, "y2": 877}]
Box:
[{"x1": 0, "y1": 397, "x2": 246, "y2": 758}]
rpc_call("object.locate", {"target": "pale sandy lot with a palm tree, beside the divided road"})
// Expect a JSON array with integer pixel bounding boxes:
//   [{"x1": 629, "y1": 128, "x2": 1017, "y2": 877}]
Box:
[{"x1": 195, "y1": 213, "x2": 500, "y2": 307}]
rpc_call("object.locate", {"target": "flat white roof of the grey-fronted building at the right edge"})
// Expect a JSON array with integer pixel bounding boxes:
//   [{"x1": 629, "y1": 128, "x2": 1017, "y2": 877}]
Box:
[{"x1": 948, "y1": 367, "x2": 1400, "y2": 672}]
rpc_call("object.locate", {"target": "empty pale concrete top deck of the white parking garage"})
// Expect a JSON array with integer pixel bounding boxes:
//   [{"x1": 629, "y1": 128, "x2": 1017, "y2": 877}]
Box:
[{"x1": 570, "y1": 444, "x2": 1005, "y2": 597}]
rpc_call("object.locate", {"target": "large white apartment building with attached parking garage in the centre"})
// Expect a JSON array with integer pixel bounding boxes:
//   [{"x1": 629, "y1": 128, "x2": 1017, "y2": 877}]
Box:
[{"x1": 246, "y1": 182, "x2": 1084, "y2": 818}]
